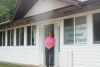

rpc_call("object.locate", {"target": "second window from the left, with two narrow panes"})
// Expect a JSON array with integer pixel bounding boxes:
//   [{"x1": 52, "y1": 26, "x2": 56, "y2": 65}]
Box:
[{"x1": 7, "y1": 29, "x2": 14, "y2": 46}]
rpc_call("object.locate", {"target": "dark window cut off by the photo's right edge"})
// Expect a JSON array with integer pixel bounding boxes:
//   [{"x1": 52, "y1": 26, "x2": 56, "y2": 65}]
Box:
[{"x1": 93, "y1": 13, "x2": 100, "y2": 44}]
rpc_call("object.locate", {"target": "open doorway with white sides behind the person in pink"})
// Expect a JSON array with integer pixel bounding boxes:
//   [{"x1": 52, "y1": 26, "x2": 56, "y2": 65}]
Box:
[{"x1": 42, "y1": 23, "x2": 60, "y2": 67}]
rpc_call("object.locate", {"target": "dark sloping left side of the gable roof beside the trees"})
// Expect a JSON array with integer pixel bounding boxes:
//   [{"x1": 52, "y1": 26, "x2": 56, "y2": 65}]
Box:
[{"x1": 12, "y1": 0, "x2": 38, "y2": 21}]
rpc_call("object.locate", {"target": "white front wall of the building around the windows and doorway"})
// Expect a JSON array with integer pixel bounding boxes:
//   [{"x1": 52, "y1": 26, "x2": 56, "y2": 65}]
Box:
[{"x1": 0, "y1": 1, "x2": 100, "y2": 67}]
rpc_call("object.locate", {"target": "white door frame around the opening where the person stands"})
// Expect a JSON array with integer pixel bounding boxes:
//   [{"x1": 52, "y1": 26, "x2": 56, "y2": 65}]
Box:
[{"x1": 40, "y1": 20, "x2": 61, "y2": 67}]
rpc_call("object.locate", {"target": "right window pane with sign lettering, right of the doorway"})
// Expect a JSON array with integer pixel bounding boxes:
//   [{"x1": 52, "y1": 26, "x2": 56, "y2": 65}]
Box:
[{"x1": 75, "y1": 16, "x2": 87, "y2": 44}]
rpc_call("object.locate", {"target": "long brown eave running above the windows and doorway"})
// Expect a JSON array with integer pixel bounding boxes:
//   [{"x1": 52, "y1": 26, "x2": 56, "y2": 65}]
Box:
[{"x1": 0, "y1": 0, "x2": 100, "y2": 29}]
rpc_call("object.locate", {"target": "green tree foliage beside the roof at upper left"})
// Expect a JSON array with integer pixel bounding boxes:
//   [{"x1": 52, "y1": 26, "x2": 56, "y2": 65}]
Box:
[{"x1": 0, "y1": 0, "x2": 18, "y2": 22}]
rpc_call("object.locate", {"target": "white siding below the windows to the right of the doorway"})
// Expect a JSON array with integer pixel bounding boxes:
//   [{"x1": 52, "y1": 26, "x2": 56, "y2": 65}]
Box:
[{"x1": 59, "y1": 45, "x2": 100, "y2": 67}]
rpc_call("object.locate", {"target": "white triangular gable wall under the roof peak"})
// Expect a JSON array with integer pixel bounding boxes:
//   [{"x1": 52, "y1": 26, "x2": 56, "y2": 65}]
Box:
[{"x1": 25, "y1": 0, "x2": 68, "y2": 17}]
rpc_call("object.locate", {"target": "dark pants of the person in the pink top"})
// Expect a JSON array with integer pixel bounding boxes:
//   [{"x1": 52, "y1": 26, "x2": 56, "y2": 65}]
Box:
[{"x1": 45, "y1": 47, "x2": 54, "y2": 67}]
